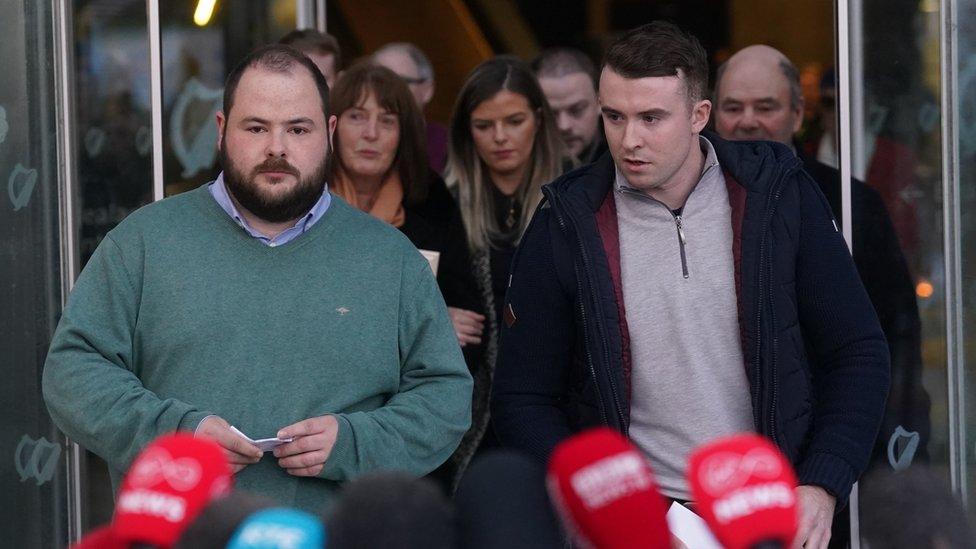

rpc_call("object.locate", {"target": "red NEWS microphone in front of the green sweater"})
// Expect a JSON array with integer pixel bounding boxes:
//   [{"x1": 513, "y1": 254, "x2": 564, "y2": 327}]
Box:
[{"x1": 112, "y1": 433, "x2": 234, "y2": 547}]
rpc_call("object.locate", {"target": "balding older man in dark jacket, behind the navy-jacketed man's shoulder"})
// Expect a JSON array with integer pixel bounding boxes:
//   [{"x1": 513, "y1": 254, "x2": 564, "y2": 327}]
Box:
[{"x1": 713, "y1": 45, "x2": 932, "y2": 470}]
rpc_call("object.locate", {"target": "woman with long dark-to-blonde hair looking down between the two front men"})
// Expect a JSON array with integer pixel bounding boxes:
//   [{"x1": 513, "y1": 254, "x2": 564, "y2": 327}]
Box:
[{"x1": 444, "y1": 56, "x2": 565, "y2": 476}]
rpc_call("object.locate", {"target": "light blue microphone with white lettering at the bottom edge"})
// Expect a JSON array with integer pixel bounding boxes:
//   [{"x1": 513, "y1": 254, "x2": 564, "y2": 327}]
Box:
[{"x1": 225, "y1": 507, "x2": 325, "y2": 549}]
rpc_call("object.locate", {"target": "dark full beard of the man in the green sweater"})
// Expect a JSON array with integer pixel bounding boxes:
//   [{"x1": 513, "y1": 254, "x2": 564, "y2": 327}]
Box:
[{"x1": 219, "y1": 144, "x2": 326, "y2": 223}]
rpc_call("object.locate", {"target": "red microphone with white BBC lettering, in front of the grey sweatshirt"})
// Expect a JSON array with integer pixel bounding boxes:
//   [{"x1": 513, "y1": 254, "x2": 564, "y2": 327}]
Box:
[{"x1": 546, "y1": 427, "x2": 671, "y2": 549}]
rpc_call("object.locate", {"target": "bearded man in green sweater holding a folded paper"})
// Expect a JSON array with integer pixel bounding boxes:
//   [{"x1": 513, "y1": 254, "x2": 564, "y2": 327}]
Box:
[{"x1": 43, "y1": 45, "x2": 471, "y2": 510}]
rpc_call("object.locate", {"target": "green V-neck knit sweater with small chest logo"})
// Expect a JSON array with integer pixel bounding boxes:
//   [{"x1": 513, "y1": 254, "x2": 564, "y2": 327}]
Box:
[{"x1": 43, "y1": 186, "x2": 471, "y2": 510}]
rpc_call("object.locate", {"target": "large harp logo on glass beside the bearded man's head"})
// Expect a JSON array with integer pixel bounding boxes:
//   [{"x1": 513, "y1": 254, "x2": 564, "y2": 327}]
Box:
[{"x1": 169, "y1": 78, "x2": 224, "y2": 177}]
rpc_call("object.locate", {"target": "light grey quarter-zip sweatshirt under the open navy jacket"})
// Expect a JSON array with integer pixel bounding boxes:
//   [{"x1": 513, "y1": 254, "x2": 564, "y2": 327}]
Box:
[{"x1": 613, "y1": 137, "x2": 754, "y2": 500}]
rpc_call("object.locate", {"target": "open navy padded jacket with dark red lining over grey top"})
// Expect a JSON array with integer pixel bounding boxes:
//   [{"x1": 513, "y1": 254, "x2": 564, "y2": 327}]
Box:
[{"x1": 492, "y1": 134, "x2": 890, "y2": 509}]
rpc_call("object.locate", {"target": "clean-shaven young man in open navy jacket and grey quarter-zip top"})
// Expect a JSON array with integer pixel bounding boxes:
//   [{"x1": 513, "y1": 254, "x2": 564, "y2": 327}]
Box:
[{"x1": 492, "y1": 23, "x2": 889, "y2": 548}]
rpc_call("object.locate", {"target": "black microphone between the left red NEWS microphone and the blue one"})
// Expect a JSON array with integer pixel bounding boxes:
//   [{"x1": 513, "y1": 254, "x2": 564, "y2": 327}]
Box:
[{"x1": 173, "y1": 491, "x2": 277, "y2": 549}]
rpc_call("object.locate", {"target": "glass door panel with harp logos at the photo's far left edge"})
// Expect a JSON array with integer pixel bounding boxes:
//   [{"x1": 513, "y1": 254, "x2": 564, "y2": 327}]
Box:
[{"x1": 0, "y1": 2, "x2": 73, "y2": 547}]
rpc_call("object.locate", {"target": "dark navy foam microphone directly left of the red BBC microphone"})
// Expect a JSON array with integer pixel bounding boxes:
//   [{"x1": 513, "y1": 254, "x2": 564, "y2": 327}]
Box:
[{"x1": 454, "y1": 450, "x2": 566, "y2": 549}]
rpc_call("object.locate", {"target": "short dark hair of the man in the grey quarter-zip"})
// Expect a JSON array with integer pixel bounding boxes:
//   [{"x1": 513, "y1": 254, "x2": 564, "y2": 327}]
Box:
[{"x1": 603, "y1": 21, "x2": 708, "y2": 101}]
